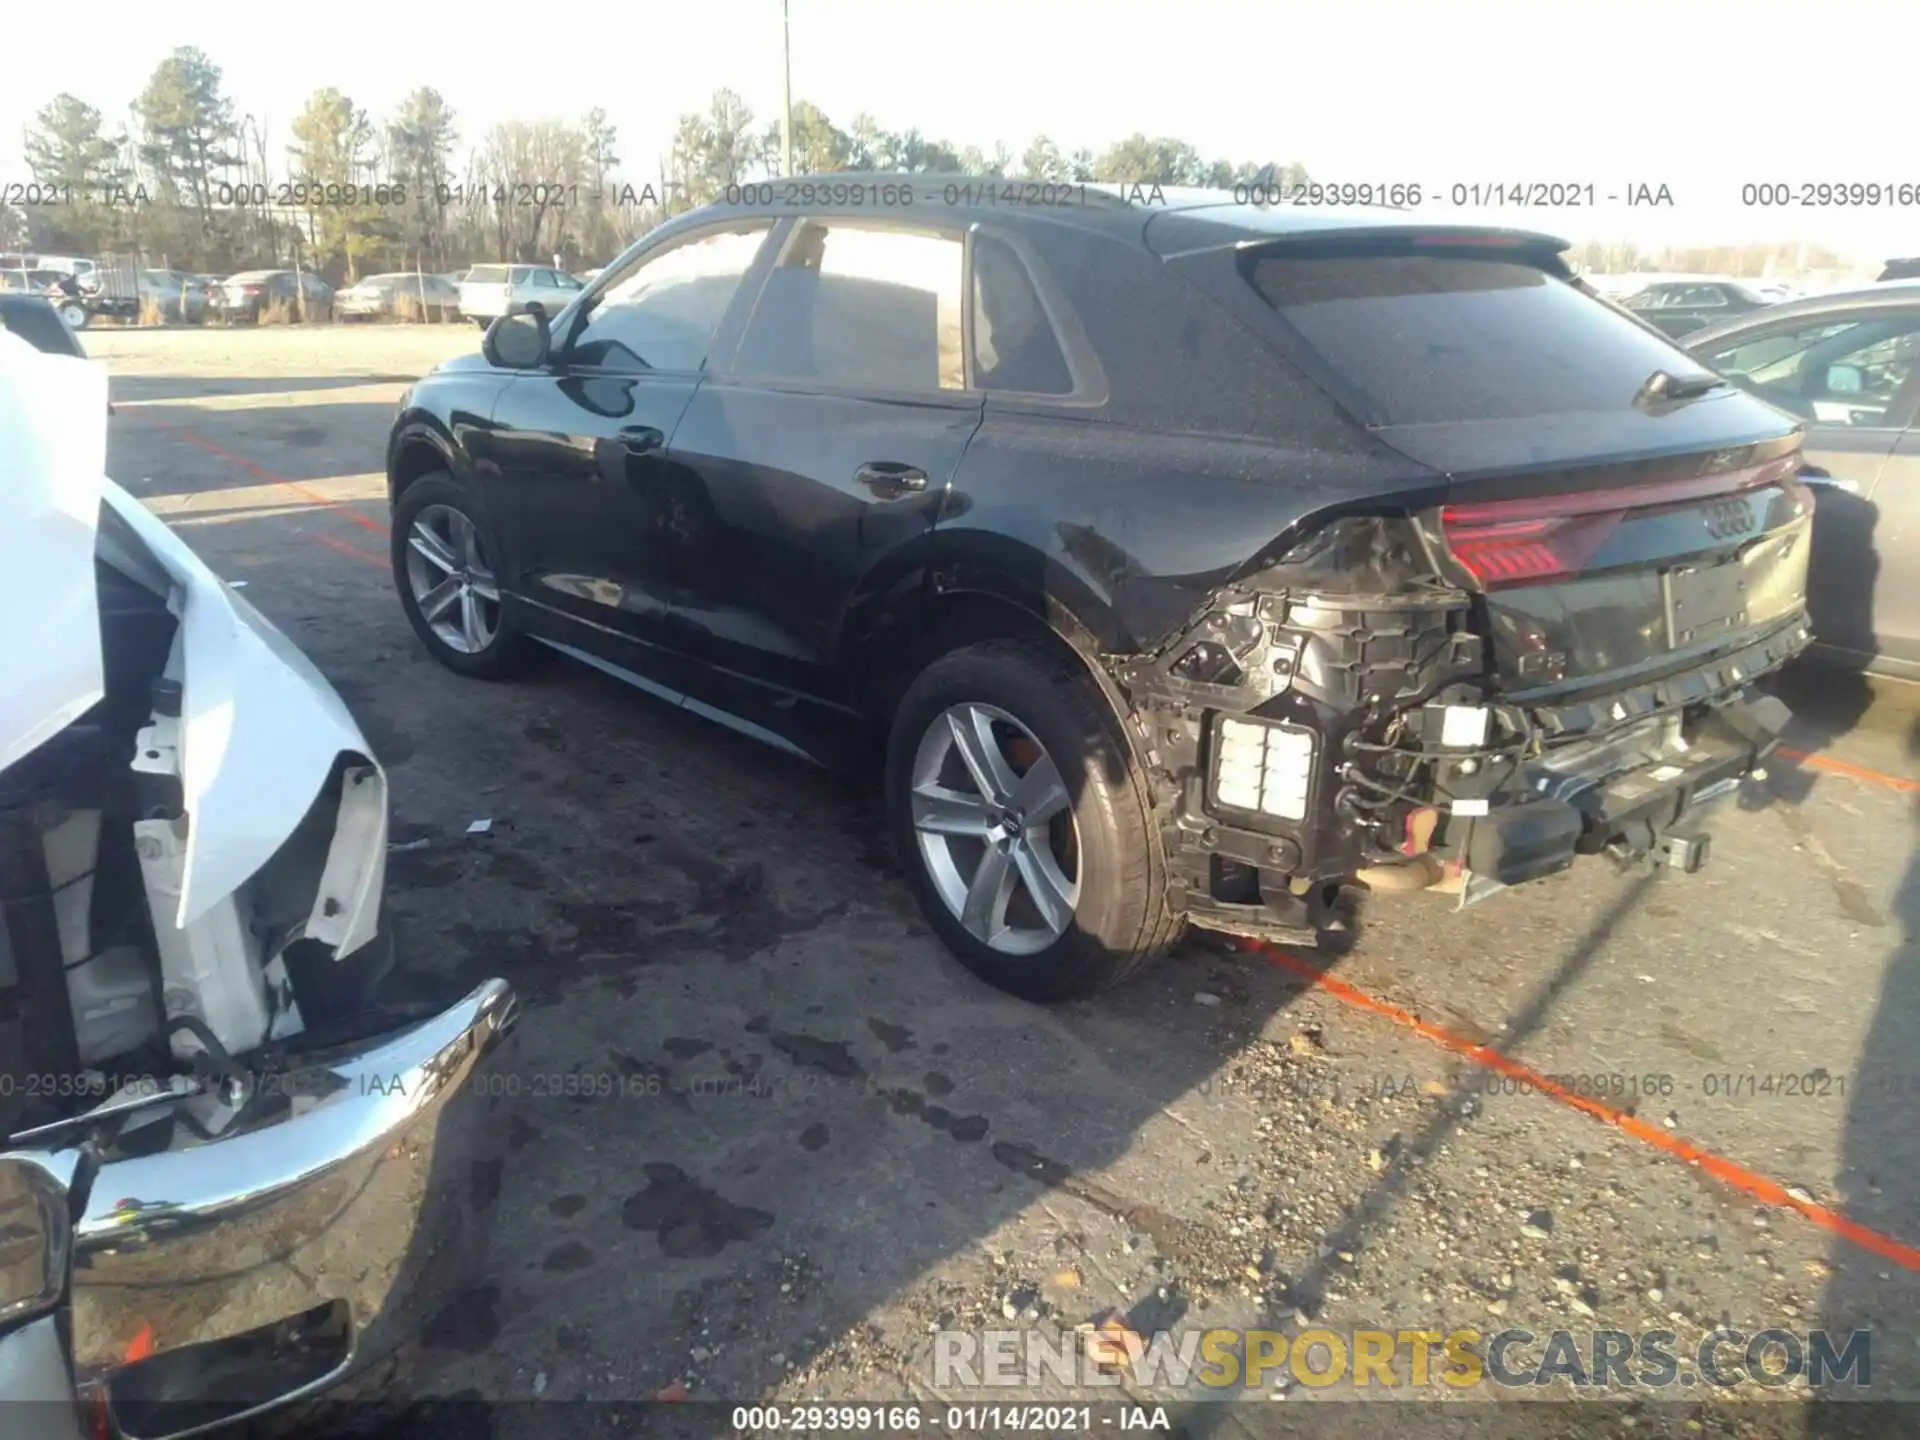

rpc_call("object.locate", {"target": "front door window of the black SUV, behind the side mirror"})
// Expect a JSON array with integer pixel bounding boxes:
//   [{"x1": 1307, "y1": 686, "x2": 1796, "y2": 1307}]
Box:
[{"x1": 568, "y1": 221, "x2": 770, "y2": 371}]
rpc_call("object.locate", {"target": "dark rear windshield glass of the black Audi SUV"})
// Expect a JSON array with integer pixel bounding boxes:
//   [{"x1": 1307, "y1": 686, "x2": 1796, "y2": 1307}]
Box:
[{"x1": 1252, "y1": 253, "x2": 1701, "y2": 424}]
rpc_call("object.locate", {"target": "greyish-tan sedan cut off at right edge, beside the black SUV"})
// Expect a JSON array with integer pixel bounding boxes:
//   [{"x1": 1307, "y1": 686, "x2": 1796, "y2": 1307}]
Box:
[{"x1": 1686, "y1": 280, "x2": 1920, "y2": 680}]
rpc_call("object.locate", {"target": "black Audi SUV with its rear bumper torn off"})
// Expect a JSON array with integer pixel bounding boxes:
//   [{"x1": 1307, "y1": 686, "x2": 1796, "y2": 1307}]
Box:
[{"x1": 388, "y1": 177, "x2": 1811, "y2": 1000}]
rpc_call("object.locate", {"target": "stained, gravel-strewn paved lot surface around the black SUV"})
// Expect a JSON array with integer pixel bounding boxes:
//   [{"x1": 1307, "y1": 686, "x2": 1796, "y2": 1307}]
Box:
[{"x1": 84, "y1": 326, "x2": 1920, "y2": 1436}]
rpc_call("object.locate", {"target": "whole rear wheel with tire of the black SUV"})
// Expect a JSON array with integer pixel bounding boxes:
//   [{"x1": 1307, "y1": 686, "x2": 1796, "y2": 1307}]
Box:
[{"x1": 887, "y1": 639, "x2": 1181, "y2": 1002}]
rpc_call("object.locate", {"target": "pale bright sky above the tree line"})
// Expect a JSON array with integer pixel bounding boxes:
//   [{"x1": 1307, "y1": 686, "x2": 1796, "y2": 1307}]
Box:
[{"x1": 0, "y1": 0, "x2": 1920, "y2": 263}]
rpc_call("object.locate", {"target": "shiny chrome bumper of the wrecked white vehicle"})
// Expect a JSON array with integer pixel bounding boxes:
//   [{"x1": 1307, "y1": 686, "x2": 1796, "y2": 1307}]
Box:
[{"x1": 71, "y1": 979, "x2": 516, "y2": 1432}]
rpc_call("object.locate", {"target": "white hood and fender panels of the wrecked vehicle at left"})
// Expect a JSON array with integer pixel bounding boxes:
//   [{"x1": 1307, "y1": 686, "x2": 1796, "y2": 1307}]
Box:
[{"x1": 0, "y1": 330, "x2": 386, "y2": 954}]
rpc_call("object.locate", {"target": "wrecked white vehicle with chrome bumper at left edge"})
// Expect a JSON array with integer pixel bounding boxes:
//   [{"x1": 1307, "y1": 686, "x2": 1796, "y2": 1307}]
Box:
[{"x1": 0, "y1": 318, "x2": 515, "y2": 1440}]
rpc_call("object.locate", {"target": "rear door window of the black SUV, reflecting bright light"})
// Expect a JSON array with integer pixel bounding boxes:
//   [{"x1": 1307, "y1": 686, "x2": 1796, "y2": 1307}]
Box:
[{"x1": 735, "y1": 221, "x2": 966, "y2": 390}]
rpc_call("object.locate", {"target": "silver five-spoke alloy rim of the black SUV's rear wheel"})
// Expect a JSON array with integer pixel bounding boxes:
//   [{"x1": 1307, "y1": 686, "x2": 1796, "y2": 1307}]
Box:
[{"x1": 910, "y1": 703, "x2": 1081, "y2": 954}]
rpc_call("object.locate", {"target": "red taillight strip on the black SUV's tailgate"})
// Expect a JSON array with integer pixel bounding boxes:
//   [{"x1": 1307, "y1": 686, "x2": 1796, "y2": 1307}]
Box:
[{"x1": 1440, "y1": 455, "x2": 1799, "y2": 586}]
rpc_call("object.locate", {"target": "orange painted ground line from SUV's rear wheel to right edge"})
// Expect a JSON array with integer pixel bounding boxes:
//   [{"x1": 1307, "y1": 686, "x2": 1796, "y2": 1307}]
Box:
[{"x1": 1240, "y1": 941, "x2": 1920, "y2": 1271}]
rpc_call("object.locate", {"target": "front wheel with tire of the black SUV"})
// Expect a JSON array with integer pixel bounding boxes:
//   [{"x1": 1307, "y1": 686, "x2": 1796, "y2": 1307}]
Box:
[{"x1": 390, "y1": 470, "x2": 534, "y2": 680}]
